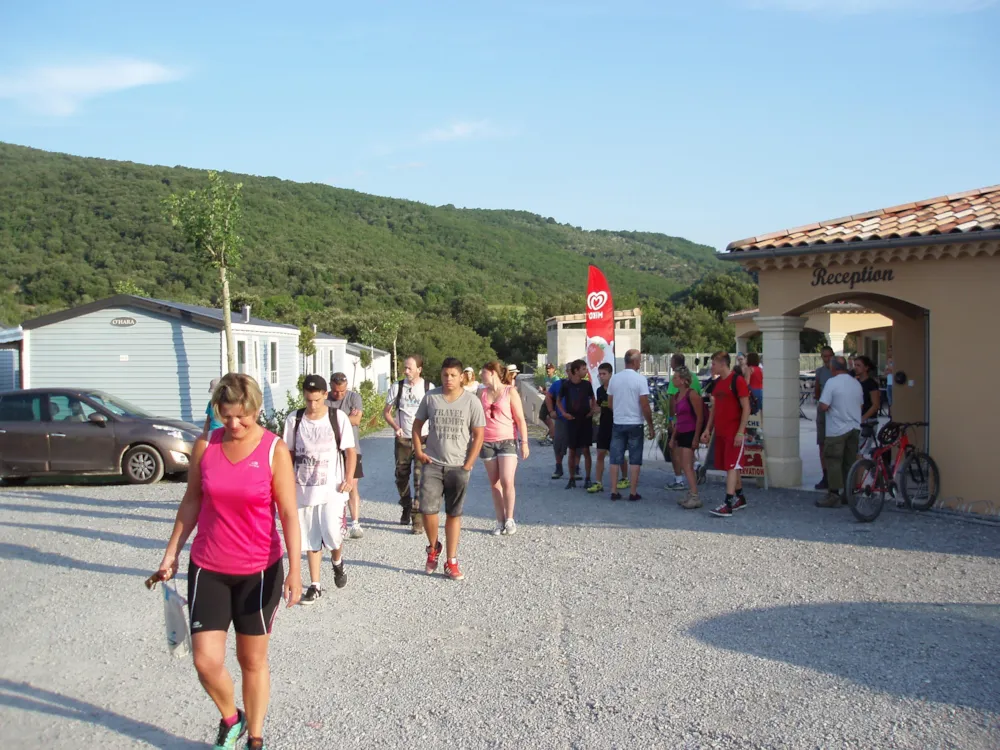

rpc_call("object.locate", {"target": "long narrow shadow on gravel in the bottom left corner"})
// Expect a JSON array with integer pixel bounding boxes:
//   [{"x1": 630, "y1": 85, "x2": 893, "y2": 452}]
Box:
[{"x1": 0, "y1": 679, "x2": 206, "y2": 750}]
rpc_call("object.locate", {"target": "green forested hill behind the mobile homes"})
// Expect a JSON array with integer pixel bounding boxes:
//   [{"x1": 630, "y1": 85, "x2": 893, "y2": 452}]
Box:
[{"x1": 0, "y1": 143, "x2": 744, "y2": 366}]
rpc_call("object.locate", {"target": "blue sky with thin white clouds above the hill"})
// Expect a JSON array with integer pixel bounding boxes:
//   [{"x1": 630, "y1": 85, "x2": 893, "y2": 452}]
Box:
[{"x1": 0, "y1": 0, "x2": 1000, "y2": 249}]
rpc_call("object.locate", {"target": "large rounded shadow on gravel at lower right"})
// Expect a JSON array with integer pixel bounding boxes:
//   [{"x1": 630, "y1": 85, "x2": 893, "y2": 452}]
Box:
[{"x1": 689, "y1": 602, "x2": 1000, "y2": 713}]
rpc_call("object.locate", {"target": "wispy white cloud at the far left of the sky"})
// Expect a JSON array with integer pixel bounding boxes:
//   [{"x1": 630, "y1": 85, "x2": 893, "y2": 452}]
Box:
[{"x1": 0, "y1": 58, "x2": 183, "y2": 117}]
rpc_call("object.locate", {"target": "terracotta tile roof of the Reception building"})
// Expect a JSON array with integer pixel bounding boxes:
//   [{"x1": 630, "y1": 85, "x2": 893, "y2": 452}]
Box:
[{"x1": 727, "y1": 185, "x2": 1000, "y2": 252}]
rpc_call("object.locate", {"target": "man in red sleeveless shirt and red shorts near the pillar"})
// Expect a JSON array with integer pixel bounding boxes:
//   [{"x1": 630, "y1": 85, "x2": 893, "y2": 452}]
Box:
[{"x1": 701, "y1": 352, "x2": 750, "y2": 518}]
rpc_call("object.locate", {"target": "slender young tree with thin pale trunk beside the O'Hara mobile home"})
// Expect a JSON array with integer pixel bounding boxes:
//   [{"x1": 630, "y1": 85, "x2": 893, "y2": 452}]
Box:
[{"x1": 164, "y1": 171, "x2": 243, "y2": 372}]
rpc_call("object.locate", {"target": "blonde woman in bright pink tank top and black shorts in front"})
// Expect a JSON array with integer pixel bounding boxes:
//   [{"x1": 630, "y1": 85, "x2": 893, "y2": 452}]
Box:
[{"x1": 158, "y1": 373, "x2": 302, "y2": 748}]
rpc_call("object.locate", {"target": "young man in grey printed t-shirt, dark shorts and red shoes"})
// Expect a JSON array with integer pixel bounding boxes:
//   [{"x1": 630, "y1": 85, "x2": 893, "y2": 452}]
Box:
[{"x1": 413, "y1": 357, "x2": 486, "y2": 581}]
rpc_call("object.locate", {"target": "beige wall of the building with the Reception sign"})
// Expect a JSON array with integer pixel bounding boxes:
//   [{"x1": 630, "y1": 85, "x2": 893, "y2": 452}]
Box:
[{"x1": 759, "y1": 256, "x2": 1000, "y2": 513}]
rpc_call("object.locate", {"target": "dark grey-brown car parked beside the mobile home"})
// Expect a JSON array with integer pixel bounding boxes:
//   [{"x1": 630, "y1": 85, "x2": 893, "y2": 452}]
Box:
[{"x1": 0, "y1": 388, "x2": 201, "y2": 484}]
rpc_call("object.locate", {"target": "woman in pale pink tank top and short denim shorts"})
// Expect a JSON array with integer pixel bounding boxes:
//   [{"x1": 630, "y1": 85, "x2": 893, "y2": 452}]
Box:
[{"x1": 479, "y1": 362, "x2": 529, "y2": 536}]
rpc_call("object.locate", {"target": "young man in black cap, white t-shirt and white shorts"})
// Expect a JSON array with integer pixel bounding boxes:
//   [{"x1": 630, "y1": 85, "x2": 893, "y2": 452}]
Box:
[{"x1": 284, "y1": 375, "x2": 358, "y2": 604}]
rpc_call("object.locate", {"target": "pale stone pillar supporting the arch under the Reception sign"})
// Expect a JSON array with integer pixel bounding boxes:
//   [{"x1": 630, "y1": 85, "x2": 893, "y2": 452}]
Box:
[{"x1": 754, "y1": 316, "x2": 806, "y2": 487}]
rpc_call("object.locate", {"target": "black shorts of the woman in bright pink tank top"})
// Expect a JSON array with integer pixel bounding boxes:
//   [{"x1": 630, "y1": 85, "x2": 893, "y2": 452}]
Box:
[{"x1": 188, "y1": 560, "x2": 285, "y2": 635}]
